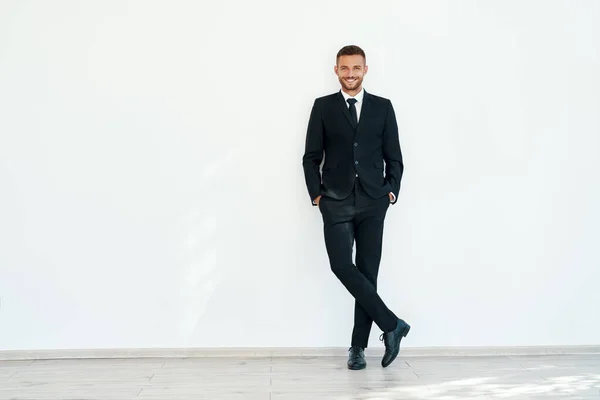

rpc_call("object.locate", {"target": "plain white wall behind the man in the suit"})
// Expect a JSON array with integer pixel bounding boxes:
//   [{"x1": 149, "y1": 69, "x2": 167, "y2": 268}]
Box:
[{"x1": 0, "y1": 0, "x2": 600, "y2": 349}]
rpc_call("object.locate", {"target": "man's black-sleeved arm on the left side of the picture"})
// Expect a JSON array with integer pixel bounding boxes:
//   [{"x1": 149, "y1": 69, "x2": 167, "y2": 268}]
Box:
[{"x1": 302, "y1": 100, "x2": 323, "y2": 205}]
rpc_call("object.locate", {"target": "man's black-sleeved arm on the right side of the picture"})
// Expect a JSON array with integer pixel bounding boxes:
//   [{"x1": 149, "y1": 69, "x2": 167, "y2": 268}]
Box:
[{"x1": 383, "y1": 100, "x2": 404, "y2": 203}]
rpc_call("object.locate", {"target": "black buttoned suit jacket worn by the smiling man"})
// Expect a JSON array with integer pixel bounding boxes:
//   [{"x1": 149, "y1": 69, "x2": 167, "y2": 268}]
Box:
[{"x1": 302, "y1": 91, "x2": 404, "y2": 205}]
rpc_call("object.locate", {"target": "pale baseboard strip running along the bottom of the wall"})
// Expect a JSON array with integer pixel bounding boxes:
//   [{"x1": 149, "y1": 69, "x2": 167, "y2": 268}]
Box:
[{"x1": 0, "y1": 345, "x2": 600, "y2": 361}]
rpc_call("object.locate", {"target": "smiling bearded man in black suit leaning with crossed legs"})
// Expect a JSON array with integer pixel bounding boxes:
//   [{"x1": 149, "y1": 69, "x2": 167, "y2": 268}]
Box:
[{"x1": 302, "y1": 46, "x2": 410, "y2": 369}]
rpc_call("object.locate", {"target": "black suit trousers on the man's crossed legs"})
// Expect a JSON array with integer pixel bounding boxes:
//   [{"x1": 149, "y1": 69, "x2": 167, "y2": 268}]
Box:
[{"x1": 319, "y1": 178, "x2": 398, "y2": 348}]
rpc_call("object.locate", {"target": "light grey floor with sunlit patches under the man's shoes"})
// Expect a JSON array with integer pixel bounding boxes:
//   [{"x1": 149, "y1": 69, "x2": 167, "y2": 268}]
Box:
[{"x1": 0, "y1": 354, "x2": 600, "y2": 400}]
